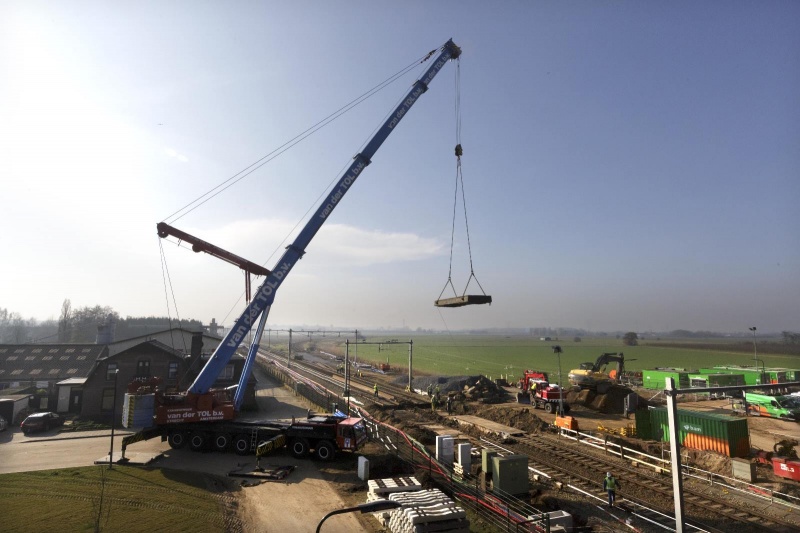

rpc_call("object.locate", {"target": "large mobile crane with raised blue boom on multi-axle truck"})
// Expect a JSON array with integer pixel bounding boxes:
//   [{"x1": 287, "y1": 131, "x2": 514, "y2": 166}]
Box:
[{"x1": 122, "y1": 40, "x2": 461, "y2": 458}]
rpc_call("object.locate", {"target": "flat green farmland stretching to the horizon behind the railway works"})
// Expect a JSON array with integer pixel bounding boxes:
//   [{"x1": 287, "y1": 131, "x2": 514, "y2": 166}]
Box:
[{"x1": 308, "y1": 335, "x2": 800, "y2": 382}]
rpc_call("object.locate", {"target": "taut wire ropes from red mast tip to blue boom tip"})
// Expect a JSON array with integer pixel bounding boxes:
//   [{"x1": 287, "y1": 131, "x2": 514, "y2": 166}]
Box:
[{"x1": 164, "y1": 52, "x2": 433, "y2": 222}]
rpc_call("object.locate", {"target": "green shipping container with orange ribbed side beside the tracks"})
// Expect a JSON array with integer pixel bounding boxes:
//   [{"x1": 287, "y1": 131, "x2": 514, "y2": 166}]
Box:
[{"x1": 636, "y1": 407, "x2": 750, "y2": 457}]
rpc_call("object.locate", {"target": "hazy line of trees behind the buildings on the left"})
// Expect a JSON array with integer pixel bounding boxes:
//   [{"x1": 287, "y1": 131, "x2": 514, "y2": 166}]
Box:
[{"x1": 0, "y1": 299, "x2": 203, "y2": 344}]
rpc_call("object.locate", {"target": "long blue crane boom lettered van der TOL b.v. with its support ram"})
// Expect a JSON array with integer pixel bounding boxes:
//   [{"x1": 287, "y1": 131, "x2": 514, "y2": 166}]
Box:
[{"x1": 188, "y1": 39, "x2": 461, "y2": 410}]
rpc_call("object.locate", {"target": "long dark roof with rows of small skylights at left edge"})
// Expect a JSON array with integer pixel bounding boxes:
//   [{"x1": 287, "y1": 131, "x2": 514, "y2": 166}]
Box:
[{"x1": 0, "y1": 344, "x2": 108, "y2": 381}]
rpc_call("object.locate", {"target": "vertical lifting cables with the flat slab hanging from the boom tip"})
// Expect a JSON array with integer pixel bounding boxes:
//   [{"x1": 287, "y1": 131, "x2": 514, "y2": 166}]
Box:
[{"x1": 435, "y1": 59, "x2": 492, "y2": 307}]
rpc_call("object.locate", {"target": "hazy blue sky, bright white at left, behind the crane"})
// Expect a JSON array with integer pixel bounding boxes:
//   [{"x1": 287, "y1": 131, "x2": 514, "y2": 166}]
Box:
[{"x1": 0, "y1": 0, "x2": 800, "y2": 333}]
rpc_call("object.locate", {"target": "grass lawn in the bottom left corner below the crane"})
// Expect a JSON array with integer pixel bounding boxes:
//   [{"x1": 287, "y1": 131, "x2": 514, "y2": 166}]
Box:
[{"x1": 0, "y1": 465, "x2": 229, "y2": 533}]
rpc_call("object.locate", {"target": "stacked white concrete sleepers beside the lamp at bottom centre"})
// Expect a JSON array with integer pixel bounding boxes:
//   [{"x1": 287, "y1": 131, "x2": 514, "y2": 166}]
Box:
[{"x1": 367, "y1": 477, "x2": 469, "y2": 533}]
